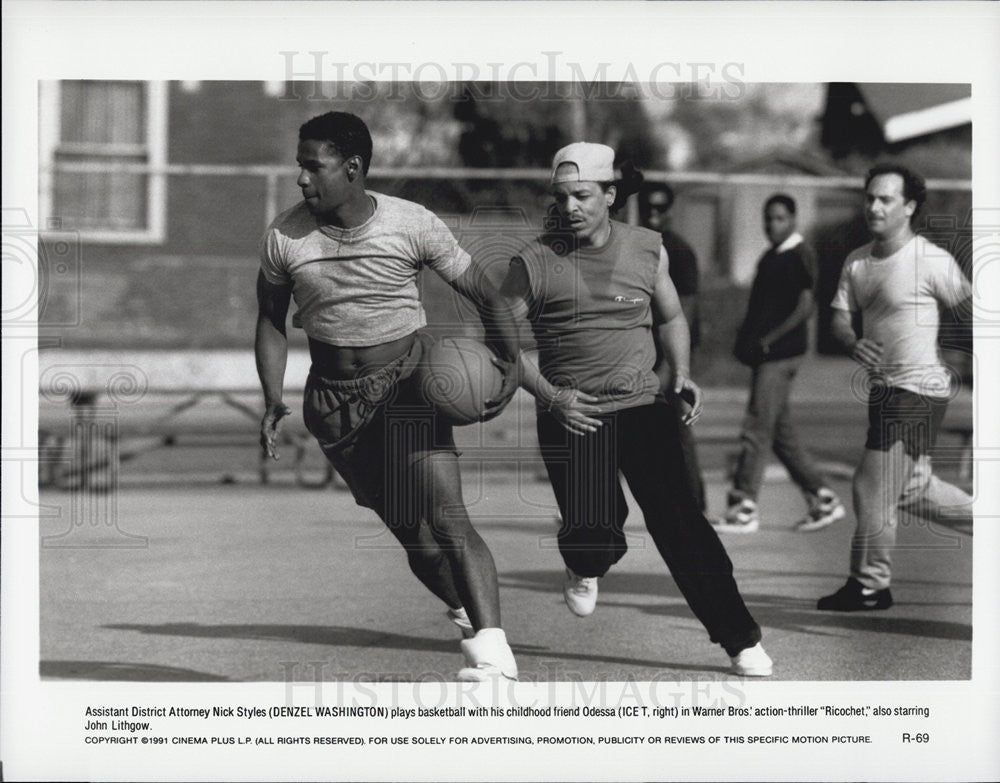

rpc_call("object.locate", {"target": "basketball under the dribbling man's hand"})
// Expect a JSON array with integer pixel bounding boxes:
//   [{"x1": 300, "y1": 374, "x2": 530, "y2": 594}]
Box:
[{"x1": 417, "y1": 337, "x2": 503, "y2": 424}]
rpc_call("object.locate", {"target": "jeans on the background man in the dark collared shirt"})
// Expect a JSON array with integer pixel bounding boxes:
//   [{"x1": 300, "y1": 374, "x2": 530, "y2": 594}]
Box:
[{"x1": 729, "y1": 356, "x2": 826, "y2": 503}]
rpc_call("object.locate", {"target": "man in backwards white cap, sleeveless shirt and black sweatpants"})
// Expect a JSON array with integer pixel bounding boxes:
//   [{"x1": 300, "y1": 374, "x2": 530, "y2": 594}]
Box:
[{"x1": 503, "y1": 142, "x2": 772, "y2": 676}]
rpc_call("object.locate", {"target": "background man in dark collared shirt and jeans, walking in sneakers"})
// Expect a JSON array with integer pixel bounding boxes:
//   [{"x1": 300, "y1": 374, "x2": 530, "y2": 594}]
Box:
[{"x1": 715, "y1": 194, "x2": 846, "y2": 533}]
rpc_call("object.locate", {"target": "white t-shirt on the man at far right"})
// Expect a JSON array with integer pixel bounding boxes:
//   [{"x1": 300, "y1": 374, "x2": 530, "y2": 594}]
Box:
[{"x1": 831, "y1": 231, "x2": 971, "y2": 397}]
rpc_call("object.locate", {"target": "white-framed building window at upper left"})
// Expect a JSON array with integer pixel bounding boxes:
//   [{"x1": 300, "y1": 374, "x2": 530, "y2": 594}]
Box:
[{"x1": 40, "y1": 81, "x2": 167, "y2": 243}]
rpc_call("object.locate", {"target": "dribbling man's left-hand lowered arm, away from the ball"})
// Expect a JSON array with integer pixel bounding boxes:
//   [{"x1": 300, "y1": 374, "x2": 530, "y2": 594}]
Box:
[{"x1": 254, "y1": 272, "x2": 292, "y2": 459}]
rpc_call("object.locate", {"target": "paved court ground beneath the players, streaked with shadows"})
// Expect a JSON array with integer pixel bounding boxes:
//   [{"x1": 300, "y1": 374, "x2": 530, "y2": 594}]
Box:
[{"x1": 41, "y1": 464, "x2": 972, "y2": 681}]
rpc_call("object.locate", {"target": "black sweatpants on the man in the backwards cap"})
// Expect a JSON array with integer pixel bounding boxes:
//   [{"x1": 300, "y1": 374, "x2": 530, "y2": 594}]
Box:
[{"x1": 537, "y1": 401, "x2": 761, "y2": 655}]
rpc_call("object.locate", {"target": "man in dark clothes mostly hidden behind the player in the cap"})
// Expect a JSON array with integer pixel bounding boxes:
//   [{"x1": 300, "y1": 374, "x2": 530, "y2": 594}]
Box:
[{"x1": 643, "y1": 185, "x2": 706, "y2": 511}]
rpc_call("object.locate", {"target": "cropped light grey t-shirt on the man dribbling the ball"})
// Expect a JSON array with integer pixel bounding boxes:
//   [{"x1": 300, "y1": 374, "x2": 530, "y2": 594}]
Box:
[{"x1": 260, "y1": 192, "x2": 471, "y2": 346}]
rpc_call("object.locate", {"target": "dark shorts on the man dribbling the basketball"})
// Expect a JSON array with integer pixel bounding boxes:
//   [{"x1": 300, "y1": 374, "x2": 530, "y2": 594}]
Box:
[{"x1": 303, "y1": 333, "x2": 459, "y2": 517}]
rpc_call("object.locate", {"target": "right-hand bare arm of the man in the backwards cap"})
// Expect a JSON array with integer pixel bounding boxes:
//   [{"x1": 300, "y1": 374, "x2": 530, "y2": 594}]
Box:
[{"x1": 652, "y1": 248, "x2": 701, "y2": 424}]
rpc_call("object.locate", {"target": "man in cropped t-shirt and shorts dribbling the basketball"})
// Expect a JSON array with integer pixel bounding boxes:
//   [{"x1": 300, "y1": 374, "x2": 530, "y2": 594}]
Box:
[{"x1": 255, "y1": 112, "x2": 519, "y2": 681}]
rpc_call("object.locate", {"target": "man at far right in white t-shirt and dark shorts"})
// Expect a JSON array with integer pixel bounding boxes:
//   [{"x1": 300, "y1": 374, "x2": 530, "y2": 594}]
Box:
[{"x1": 817, "y1": 164, "x2": 971, "y2": 612}]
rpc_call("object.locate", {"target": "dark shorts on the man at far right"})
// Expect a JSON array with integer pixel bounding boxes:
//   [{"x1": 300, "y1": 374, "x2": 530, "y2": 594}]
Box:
[{"x1": 865, "y1": 386, "x2": 948, "y2": 459}]
